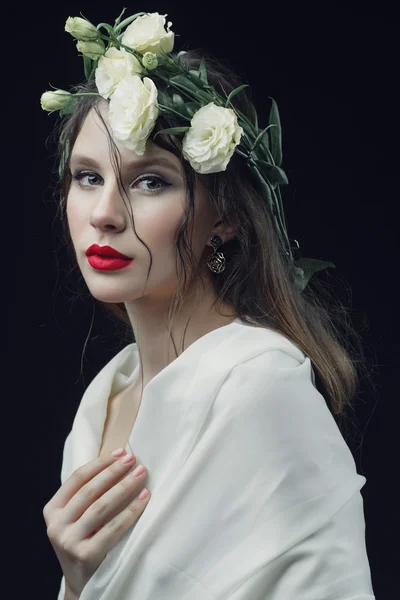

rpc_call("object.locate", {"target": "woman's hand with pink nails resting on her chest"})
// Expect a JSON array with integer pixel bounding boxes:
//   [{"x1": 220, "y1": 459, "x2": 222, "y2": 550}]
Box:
[{"x1": 43, "y1": 451, "x2": 150, "y2": 598}]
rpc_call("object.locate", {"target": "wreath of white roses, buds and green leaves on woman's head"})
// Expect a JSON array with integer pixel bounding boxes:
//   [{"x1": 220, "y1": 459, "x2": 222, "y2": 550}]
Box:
[{"x1": 41, "y1": 8, "x2": 335, "y2": 292}]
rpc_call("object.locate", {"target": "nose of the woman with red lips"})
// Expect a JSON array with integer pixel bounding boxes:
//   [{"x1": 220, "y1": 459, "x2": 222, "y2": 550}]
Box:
[{"x1": 90, "y1": 180, "x2": 127, "y2": 231}]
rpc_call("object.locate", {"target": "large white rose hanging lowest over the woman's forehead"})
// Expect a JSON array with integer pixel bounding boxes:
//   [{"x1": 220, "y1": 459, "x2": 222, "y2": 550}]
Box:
[{"x1": 108, "y1": 75, "x2": 159, "y2": 156}]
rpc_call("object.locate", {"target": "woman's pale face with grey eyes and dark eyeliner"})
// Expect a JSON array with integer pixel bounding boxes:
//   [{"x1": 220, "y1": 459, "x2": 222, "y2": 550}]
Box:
[{"x1": 67, "y1": 103, "x2": 218, "y2": 303}]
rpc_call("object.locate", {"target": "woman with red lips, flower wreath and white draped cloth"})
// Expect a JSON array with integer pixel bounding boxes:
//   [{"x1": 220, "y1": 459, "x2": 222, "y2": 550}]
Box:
[{"x1": 42, "y1": 13, "x2": 374, "y2": 600}]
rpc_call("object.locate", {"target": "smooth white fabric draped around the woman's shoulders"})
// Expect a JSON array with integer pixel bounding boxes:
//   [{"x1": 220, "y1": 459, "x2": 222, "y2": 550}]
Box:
[{"x1": 58, "y1": 319, "x2": 375, "y2": 600}]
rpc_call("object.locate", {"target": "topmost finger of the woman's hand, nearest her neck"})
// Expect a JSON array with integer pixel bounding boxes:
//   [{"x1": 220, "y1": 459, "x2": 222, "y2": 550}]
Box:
[{"x1": 43, "y1": 449, "x2": 130, "y2": 513}]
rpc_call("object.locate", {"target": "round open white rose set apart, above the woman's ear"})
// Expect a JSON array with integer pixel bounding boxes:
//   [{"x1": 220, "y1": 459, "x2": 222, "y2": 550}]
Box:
[{"x1": 182, "y1": 102, "x2": 243, "y2": 174}]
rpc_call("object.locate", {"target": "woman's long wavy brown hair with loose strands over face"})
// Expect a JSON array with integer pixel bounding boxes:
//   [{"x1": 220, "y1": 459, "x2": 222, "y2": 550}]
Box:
[{"x1": 47, "y1": 49, "x2": 373, "y2": 438}]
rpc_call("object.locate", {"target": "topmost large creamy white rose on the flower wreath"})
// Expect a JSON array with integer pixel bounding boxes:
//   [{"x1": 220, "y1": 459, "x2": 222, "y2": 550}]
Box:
[{"x1": 121, "y1": 13, "x2": 175, "y2": 55}]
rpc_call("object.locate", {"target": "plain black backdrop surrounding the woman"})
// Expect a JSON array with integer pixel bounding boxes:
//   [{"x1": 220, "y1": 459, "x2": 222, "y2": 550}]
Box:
[{"x1": 18, "y1": 1, "x2": 400, "y2": 600}]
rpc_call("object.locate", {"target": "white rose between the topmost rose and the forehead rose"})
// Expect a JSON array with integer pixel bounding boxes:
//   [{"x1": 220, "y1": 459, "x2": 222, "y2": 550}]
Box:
[{"x1": 95, "y1": 48, "x2": 143, "y2": 99}]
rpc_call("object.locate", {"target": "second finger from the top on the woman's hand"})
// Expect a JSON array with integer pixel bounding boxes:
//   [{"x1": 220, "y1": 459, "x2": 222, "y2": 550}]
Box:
[{"x1": 58, "y1": 454, "x2": 140, "y2": 525}]
